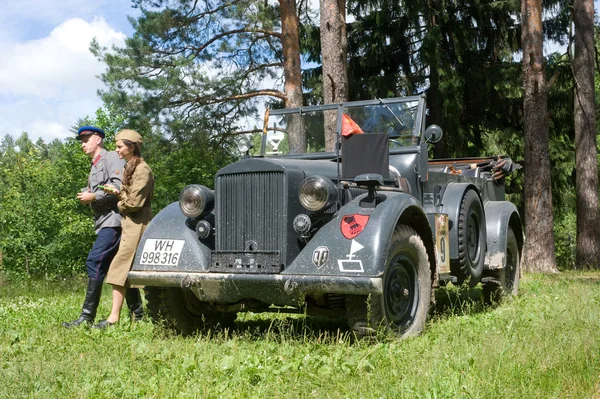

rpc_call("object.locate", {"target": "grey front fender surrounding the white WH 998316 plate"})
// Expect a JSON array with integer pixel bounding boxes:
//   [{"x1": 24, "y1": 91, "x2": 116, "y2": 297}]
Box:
[{"x1": 132, "y1": 202, "x2": 211, "y2": 272}]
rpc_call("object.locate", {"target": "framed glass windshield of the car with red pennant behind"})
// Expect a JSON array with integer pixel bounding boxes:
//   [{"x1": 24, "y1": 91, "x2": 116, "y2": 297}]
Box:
[{"x1": 261, "y1": 97, "x2": 420, "y2": 156}]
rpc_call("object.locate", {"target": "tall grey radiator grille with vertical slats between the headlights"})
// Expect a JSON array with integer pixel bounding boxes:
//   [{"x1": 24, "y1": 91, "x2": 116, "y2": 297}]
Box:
[{"x1": 215, "y1": 172, "x2": 287, "y2": 252}]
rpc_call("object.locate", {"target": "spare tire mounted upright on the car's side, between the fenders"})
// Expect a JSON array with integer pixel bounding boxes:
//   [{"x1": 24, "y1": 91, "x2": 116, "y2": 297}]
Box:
[{"x1": 450, "y1": 189, "x2": 486, "y2": 287}]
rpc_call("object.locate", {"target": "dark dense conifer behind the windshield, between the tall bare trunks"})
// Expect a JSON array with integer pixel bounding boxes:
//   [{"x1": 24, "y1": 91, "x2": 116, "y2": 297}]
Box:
[{"x1": 348, "y1": 0, "x2": 521, "y2": 157}]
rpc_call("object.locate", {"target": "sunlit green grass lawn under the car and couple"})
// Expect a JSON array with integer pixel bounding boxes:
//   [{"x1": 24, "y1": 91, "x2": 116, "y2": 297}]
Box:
[{"x1": 0, "y1": 272, "x2": 600, "y2": 398}]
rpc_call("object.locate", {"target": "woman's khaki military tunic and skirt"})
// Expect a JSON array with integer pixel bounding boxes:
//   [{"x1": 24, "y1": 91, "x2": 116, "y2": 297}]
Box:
[{"x1": 106, "y1": 160, "x2": 154, "y2": 287}]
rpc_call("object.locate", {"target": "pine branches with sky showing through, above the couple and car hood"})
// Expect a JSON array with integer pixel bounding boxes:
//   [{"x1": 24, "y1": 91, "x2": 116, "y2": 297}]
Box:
[{"x1": 91, "y1": 0, "x2": 283, "y2": 205}]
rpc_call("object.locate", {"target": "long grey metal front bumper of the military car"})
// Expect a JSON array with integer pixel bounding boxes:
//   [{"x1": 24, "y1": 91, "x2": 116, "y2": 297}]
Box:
[{"x1": 129, "y1": 271, "x2": 383, "y2": 306}]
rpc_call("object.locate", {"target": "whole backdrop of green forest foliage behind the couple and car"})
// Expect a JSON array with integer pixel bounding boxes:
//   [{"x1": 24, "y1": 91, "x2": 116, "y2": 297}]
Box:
[{"x1": 0, "y1": 0, "x2": 600, "y2": 280}]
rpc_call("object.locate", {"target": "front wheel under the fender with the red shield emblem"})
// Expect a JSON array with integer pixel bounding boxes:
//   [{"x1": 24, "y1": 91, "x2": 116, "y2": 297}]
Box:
[{"x1": 348, "y1": 225, "x2": 431, "y2": 337}]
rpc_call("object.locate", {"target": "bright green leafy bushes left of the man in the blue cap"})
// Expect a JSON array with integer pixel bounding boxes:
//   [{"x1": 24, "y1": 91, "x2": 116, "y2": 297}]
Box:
[{"x1": 0, "y1": 139, "x2": 93, "y2": 279}]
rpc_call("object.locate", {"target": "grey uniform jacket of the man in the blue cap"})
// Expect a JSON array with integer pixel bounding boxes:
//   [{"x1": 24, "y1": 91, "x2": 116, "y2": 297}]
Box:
[{"x1": 88, "y1": 149, "x2": 125, "y2": 233}]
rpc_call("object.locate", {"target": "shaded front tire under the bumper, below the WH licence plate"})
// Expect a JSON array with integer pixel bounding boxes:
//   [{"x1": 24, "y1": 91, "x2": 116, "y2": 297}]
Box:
[{"x1": 145, "y1": 287, "x2": 237, "y2": 335}]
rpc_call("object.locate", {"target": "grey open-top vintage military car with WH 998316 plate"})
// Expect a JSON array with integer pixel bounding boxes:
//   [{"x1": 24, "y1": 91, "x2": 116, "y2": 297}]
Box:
[{"x1": 129, "y1": 96, "x2": 523, "y2": 336}]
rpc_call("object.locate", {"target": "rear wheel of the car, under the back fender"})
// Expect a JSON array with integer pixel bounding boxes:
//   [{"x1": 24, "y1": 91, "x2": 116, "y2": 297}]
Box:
[{"x1": 483, "y1": 227, "x2": 521, "y2": 304}]
